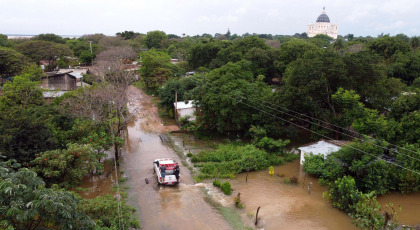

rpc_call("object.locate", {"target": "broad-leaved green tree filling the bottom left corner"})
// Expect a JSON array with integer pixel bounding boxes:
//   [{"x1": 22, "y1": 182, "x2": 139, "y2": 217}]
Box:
[{"x1": 0, "y1": 162, "x2": 95, "y2": 229}]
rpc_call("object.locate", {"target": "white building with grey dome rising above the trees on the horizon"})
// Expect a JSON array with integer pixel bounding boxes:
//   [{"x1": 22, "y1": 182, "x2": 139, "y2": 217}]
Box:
[{"x1": 308, "y1": 7, "x2": 338, "y2": 39}]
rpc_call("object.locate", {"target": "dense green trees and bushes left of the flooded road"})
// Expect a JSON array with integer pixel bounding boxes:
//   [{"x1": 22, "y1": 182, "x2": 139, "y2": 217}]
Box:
[{"x1": 0, "y1": 34, "x2": 140, "y2": 229}]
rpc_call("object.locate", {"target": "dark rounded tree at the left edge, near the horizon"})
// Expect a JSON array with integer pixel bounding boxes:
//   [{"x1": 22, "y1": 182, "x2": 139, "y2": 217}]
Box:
[{"x1": 0, "y1": 46, "x2": 28, "y2": 77}]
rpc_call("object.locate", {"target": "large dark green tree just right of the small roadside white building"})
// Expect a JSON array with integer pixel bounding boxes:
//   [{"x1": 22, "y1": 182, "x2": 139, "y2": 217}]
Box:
[{"x1": 194, "y1": 61, "x2": 278, "y2": 132}]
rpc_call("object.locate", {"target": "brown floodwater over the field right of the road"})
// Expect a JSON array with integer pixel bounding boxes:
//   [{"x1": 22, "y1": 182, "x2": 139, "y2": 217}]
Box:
[{"x1": 171, "y1": 134, "x2": 420, "y2": 229}]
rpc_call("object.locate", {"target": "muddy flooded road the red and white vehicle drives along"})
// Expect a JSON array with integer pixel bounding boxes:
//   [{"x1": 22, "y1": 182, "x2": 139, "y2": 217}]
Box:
[{"x1": 121, "y1": 87, "x2": 231, "y2": 230}]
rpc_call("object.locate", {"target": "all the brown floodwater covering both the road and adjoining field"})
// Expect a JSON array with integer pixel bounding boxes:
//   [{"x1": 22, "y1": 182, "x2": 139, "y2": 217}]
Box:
[{"x1": 82, "y1": 86, "x2": 420, "y2": 230}]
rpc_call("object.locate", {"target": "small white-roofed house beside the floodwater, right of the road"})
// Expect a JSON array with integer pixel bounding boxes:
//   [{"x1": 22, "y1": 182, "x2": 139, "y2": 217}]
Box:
[{"x1": 298, "y1": 140, "x2": 347, "y2": 165}]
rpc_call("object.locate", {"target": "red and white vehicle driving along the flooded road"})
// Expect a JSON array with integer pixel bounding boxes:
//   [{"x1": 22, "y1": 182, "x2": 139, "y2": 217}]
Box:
[{"x1": 153, "y1": 158, "x2": 179, "y2": 185}]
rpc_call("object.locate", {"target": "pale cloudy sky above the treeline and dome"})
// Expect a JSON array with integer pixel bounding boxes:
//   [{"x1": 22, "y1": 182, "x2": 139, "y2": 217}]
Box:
[{"x1": 0, "y1": 0, "x2": 420, "y2": 37}]
